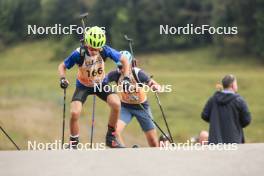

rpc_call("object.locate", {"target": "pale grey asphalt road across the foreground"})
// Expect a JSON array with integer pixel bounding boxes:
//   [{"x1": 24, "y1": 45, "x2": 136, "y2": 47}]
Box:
[{"x1": 0, "y1": 144, "x2": 264, "y2": 176}]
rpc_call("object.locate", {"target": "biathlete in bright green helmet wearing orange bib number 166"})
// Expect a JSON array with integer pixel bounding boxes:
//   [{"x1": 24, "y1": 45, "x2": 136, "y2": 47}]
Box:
[{"x1": 58, "y1": 26, "x2": 130, "y2": 148}]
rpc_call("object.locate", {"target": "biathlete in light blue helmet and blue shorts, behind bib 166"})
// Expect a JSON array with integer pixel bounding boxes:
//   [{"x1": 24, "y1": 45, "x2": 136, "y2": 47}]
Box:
[{"x1": 104, "y1": 51, "x2": 160, "y2": 147}]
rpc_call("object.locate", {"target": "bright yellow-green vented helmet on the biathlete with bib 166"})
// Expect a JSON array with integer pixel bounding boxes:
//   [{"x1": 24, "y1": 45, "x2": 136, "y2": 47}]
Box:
[{"x1": 84, "y1": 26, "x2": 106, "y2": 49}]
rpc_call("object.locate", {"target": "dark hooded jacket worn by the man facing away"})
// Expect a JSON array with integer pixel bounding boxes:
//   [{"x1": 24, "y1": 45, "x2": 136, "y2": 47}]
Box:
[{"x1": 202, "y1": 92, "x2": 251, "y2": 144}]
